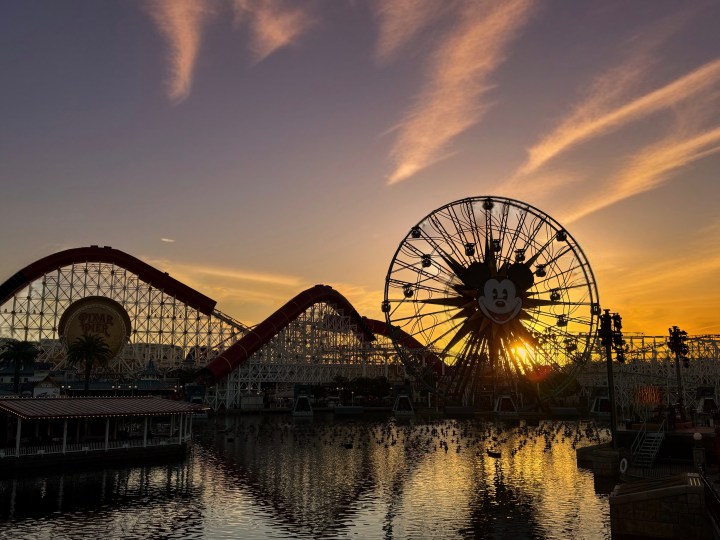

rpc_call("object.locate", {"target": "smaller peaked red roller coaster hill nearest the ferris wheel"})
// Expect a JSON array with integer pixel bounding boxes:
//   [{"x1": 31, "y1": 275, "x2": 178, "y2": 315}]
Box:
[{"x1": 199, "y1": 285, "x2": 406, "y2": 409}]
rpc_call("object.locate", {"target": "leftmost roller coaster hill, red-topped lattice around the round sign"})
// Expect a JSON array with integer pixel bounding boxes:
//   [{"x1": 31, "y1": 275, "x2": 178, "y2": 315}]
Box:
[{"x1": 0, "y1": 246, "x2": 248, "y2": 379}]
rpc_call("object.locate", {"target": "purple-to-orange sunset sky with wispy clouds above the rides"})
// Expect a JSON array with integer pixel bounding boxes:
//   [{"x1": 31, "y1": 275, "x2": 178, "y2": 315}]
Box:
[{"x1": 0, "y1": 0, "x2": 720, "y2": 335}]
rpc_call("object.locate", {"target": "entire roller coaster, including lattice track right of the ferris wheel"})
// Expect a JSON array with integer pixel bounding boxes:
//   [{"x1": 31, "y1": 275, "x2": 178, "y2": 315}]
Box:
[{"x1": 0, "y1": 246, "x2": 720, "y2": 409}]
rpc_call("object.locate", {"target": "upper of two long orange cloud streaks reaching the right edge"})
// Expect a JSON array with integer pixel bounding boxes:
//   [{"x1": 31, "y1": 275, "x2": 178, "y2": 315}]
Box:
[{"x1": 519, "y1": 59, "x2": 720, "y2": 175}]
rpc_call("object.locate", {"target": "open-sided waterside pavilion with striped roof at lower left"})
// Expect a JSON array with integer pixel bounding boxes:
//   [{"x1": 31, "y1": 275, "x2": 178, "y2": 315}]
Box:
[{"x1": 0, "y1": 397, "x2": 202, "y2": 473}]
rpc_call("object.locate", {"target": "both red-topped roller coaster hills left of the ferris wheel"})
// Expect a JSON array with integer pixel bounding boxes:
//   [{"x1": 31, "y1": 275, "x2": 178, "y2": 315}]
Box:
[{"x1": 0, "y1": 246, "x2": 414, "y2": 409}]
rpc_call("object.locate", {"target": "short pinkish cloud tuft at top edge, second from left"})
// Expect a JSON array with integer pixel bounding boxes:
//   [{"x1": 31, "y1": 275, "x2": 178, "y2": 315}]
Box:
[{"x1": 233, "y1": 0, "x2": 314, "y2": 62}]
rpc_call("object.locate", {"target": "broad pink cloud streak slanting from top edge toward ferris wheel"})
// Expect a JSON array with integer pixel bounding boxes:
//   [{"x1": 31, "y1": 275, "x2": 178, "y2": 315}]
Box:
[{"x1": 385, "y1": 0, "x2": 534, "y2": 184}]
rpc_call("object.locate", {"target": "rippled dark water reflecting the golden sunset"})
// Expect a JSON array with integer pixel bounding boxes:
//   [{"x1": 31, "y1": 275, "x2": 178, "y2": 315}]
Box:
[{"x1": 0, "y1": 416, "x2": 610, "y2": 540}]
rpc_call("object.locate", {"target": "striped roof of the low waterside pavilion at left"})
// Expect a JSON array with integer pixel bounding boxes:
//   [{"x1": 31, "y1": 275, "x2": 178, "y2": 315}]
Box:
[{"x1": 0, "y1": 397, "x2": 205, "y2": 420}]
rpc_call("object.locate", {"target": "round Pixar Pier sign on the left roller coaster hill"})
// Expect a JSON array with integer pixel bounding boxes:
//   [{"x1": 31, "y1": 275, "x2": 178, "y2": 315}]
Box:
[{"x1": 58, "y1": 296, "x2": 131, "y2": 357}]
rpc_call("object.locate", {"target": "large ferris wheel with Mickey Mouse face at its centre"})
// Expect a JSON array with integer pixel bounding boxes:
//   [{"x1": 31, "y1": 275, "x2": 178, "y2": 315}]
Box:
[{"x1": 382, "y1": 197, "x2": 600, "y2": 399}]
